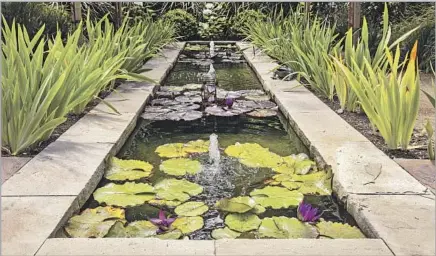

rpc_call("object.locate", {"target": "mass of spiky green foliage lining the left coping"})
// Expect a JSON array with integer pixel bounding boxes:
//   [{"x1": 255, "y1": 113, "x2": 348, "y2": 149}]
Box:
[{"x1": 2, "y1": 17, "x2": 174, "y2": 155}]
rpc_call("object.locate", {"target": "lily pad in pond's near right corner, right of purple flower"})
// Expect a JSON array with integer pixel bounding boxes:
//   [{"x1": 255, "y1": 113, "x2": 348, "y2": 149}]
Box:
[{"x1": 316, "y1": 221, "x2": 365, "y2": 239}]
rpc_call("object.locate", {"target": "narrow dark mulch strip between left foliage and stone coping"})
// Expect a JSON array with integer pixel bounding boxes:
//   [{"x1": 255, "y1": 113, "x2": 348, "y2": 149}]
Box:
[{"x1": 1, "y1": 86, "x2": 116, "y2": 157}]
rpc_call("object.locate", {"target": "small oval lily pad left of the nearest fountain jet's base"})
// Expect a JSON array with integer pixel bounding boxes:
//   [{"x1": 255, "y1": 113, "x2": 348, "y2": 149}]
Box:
[{"x1": 159, "y1": 158, "x2": 201, "y2": 176}]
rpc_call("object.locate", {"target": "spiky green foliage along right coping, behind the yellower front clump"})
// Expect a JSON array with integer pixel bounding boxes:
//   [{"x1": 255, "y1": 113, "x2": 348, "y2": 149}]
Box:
[{"x1": 244, "y1": 8, "x2": 340, "y2": 99}]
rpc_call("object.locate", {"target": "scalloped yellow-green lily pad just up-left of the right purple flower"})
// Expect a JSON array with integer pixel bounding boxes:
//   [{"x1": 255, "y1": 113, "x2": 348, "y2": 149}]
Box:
[{"x1": 250, "y1": 186, "x2": 303, "y2": 209}]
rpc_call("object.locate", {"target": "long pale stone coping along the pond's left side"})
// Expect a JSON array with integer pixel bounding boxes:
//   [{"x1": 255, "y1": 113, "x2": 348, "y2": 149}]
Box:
[{"x1": 1, "y1": 43, "x2": 185, "y2": 255}]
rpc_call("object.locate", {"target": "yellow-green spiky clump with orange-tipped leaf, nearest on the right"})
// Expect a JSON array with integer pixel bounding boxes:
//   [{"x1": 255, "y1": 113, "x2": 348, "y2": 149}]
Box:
[{"x1": 335, "y1": 42, "x2": 420, "y2": 149}]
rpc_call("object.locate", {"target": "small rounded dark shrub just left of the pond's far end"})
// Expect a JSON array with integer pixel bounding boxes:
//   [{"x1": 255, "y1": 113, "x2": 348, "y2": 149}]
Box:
[{"x1": 163, "y1": 9, "x2": 197, "y2": 40}]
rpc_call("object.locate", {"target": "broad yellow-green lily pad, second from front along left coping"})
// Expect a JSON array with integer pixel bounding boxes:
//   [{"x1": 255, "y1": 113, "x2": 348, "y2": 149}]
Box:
[{"x1": 93, "y1": 182, "x2": 155, "y2": 207}]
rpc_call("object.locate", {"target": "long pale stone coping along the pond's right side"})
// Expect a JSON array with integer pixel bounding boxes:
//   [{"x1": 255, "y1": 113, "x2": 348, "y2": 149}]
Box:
[{"x1": 237, "y1": 43, "x2": 435, "y2": 255}]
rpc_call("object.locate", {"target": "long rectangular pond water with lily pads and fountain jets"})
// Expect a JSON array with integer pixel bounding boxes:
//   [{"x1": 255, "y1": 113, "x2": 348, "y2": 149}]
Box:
[{"x1": 60, "y1": 42, "x2": 364, "y2": 240}]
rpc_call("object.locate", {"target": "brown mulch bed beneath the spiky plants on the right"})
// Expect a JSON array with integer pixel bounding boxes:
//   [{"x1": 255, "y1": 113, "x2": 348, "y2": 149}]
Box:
[{"x1": 314, "y1": 92, "x2": 428, "y2": 159}]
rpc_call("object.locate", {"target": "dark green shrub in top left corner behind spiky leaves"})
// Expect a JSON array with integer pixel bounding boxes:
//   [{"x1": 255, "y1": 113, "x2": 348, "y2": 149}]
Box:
[{"x1": 1, "y1": 2, "x2": 71, "y2": 37}]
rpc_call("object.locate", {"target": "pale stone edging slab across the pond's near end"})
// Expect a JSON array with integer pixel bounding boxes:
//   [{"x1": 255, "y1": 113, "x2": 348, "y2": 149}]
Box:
[{"x1": 36, "y1": 238, "x2": 393, "y2": 256}]
